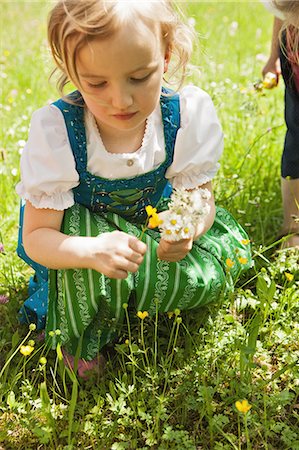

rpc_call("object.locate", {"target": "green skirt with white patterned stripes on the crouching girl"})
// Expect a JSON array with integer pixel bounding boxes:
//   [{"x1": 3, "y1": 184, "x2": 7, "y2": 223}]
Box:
[{"x1": 46, "y1": 204, "x2": 252, "y2": 360}]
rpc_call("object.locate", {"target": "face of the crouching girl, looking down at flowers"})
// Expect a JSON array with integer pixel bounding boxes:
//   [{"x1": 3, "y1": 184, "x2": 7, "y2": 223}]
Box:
[{"x1": 77, "y1": 20, "x2": 169, "y2": 136}]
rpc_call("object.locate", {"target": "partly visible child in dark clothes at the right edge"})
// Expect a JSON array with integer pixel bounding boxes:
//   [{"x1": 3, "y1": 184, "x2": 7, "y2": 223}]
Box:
[{"x1": 262, "y1": 0, "x2": 299, "y2": 248}]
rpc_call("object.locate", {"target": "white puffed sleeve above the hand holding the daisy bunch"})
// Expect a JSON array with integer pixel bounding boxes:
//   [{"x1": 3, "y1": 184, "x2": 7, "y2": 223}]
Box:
[{"x1": 166, "y1": 86, "x2": 223, "y2": 189}]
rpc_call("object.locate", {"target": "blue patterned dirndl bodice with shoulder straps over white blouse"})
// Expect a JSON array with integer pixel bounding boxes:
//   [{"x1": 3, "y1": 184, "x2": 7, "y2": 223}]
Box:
[{"x1": 54, "y1": 88, "x2": 180, "y2": 223}]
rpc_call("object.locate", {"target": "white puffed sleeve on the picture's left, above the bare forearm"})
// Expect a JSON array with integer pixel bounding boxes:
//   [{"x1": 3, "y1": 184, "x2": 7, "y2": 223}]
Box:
[{"x1": 16, "y1": 105, "x2": 79, "y2": 210}]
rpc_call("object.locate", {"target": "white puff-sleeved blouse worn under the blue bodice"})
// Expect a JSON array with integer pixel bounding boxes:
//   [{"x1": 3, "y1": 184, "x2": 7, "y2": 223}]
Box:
[{"x1": 16, "y1": 86, "x2": 223, "y2": 210}]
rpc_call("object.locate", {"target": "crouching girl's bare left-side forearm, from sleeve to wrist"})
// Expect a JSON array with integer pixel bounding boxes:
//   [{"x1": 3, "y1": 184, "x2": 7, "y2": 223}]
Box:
[{"x1": 23, "y1": 228, "x2": 96, "y2": 269}]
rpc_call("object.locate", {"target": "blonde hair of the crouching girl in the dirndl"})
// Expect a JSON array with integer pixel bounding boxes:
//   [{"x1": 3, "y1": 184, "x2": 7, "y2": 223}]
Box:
[{"x1": 48, "y1": 0, "x2": 194, "y2": 95}]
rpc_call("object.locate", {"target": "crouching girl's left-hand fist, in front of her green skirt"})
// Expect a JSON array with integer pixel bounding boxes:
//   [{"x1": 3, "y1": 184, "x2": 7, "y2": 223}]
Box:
[{"x1": 90, "y1": 231, "x2": 146, "y2": 279}]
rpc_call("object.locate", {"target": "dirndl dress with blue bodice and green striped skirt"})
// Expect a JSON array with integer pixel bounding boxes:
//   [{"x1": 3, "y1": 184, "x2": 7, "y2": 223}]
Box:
[{"x1": 19, "y1": 90, "x2": 252, "y2": 360}]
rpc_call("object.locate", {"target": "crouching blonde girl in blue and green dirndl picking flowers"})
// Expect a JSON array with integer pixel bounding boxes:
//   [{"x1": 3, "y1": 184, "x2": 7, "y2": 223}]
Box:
[{"x1": 17, "y1": 0, "x2": 251, "y2": 374}]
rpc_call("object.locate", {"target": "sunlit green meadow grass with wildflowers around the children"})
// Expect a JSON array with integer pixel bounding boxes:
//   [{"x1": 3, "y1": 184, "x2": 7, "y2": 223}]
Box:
[{"x1": 0, "y1": 1, "x2": 299, "y2": 450}]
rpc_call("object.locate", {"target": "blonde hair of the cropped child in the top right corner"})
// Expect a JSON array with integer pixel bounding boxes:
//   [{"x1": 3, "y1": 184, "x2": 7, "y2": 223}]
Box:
[{"x1": 272, "y1": 0, "x2": 299, "y2": 64}]
